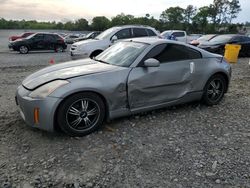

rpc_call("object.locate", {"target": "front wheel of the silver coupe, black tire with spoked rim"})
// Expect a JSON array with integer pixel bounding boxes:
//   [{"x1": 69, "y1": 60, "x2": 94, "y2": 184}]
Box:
[{"x1": 56, "y1": 92, "x2": 105, "y2": 136}]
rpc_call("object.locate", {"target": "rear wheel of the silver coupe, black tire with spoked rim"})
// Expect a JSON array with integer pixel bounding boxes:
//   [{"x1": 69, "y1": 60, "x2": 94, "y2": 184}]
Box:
[{"x1": 202, "y1": 74, "x2": 227, "y2": 106}]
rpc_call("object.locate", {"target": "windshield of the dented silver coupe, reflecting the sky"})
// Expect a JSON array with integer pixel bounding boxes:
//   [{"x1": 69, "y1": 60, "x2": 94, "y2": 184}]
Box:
[{"x1": 95, "y1": 42, "x2": 148, "y2": 67}]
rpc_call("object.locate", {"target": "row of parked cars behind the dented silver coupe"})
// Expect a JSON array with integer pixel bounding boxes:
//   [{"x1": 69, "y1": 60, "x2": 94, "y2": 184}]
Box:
[{"x1": 9, "y1": 25, "x2": 250, "y2": 59}]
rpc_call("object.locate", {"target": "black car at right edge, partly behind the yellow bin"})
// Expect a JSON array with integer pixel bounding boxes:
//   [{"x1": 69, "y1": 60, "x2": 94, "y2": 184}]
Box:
[{"x1": 198, "y1": 34, "x2": 250, "y2": 57}]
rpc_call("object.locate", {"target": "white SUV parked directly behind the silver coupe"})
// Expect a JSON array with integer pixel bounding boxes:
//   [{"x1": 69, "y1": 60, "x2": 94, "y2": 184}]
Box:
[{"x1": 70, "y1": 25, "x2": 160, "y2": 59}]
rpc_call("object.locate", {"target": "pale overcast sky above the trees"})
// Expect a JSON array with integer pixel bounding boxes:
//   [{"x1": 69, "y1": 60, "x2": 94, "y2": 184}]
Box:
[{"x1": 0, "y1": 0, "x2": 250, "y2": 22}]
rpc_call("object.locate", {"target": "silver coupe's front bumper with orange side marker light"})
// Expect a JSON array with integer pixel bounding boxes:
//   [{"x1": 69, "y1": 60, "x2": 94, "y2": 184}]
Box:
[{"x1": 16, "y1": 86, "x2": 62, "y2": 131}]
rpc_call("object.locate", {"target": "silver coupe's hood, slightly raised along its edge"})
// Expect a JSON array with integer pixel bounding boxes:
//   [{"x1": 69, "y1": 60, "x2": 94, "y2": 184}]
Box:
[{"x1": 22, "y1": 59, "x2": 117, "y2": 90}]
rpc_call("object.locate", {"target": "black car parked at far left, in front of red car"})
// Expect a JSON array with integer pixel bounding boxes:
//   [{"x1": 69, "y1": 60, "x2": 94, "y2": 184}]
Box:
[{"x1": 9, "y1": 33, "x2": 67, "y2": 54}]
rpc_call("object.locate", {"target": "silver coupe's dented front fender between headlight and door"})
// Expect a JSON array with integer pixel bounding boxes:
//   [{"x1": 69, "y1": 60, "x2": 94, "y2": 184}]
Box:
[{"x1": 50, "y1": 67, "x2": 130, "y2": 114}]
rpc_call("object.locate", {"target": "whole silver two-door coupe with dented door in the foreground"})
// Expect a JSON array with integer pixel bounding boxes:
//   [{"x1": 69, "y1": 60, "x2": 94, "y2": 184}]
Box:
[{"x1": 16, "y1": 38, "x2": 231, "y2": 136}]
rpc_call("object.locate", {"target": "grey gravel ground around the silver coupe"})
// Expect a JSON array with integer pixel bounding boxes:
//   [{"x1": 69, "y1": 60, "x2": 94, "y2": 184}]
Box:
[{"x1": 0, "y1": 45, "x2": 250, "y2": 188}]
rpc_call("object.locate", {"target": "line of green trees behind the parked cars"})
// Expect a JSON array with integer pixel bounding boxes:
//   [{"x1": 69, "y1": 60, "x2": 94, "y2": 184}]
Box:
[{"x1": 0, "y1": 0, "x2": 243, "y2": 33}]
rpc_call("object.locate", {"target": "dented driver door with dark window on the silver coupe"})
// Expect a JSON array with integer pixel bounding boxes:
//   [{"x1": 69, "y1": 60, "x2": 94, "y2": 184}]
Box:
[{"x1": 128, "y1": 44, "x2": 201, "y2": 111}]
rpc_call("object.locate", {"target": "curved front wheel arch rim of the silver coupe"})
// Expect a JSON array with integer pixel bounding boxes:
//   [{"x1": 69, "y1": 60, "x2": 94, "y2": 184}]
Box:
[{"x1": 53, "y1": 90, "x2": 109, "y2": 130}]
